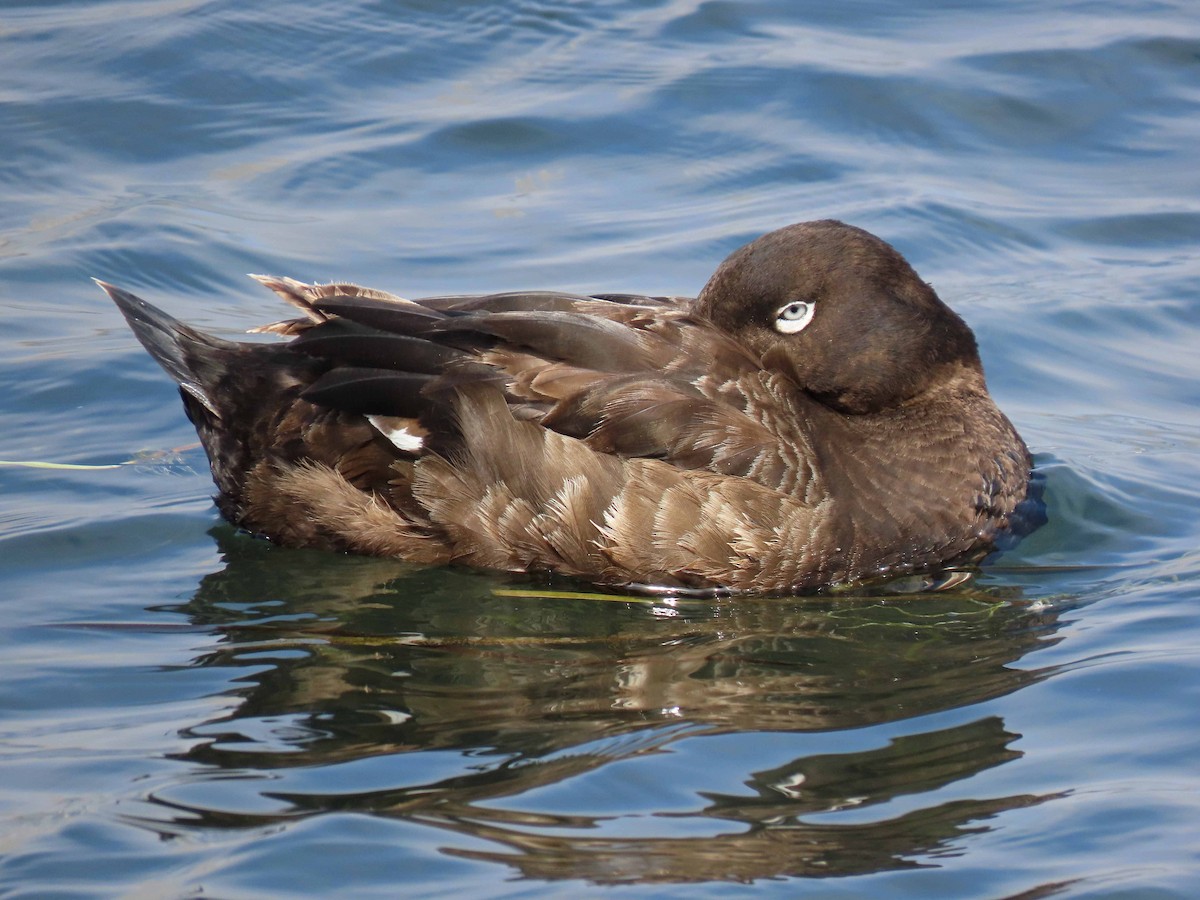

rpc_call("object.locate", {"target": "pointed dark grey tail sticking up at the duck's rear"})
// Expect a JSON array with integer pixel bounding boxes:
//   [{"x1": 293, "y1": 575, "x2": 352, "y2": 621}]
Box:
[{"x1": 92, "y1": 278, "x2": 238, "y2": 419}]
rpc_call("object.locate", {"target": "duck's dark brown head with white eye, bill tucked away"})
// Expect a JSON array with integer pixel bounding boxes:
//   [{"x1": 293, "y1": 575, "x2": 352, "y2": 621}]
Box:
[{"x1": 697, "y1": 220, "x2": 982, "y2": 413}]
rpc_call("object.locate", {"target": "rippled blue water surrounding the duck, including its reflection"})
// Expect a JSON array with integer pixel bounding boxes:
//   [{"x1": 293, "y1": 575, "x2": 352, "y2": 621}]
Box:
[{"x1": 0, "y1": 0, "x2": 1200, "y2": 898}]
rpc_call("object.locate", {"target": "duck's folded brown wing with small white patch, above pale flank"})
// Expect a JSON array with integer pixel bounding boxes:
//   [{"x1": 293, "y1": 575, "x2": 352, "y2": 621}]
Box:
[{"x1": 263, "y1": 280, "x2": 815, "y2": 498}]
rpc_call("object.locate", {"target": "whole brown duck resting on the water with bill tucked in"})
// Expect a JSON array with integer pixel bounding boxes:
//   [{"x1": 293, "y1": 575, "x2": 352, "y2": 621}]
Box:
[{"x1": 97, "y1": 220, "x2": 1032, "y2": 595}]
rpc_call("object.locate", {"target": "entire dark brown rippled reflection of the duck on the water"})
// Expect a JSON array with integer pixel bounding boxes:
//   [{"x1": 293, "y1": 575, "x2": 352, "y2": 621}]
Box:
[{"x1": 145, "y1": 530, "x2": 1056, "y2": 882}]
